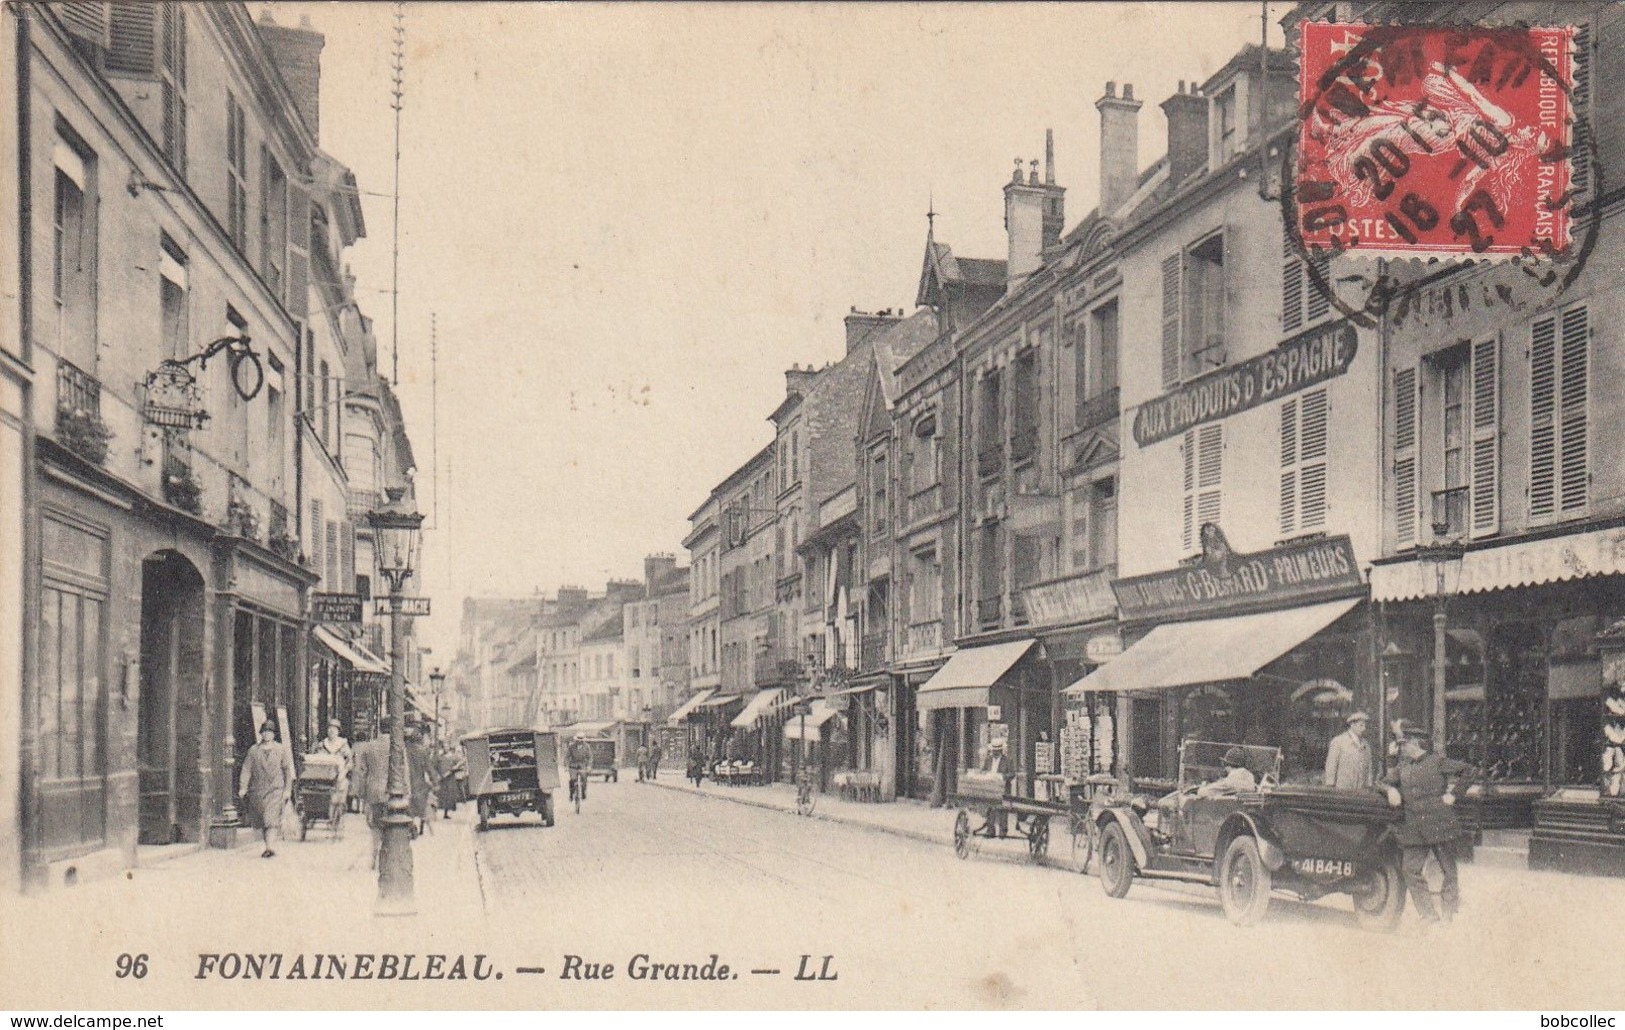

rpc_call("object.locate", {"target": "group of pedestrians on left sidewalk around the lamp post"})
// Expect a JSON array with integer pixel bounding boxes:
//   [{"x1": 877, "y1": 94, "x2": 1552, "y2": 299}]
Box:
[{"x1": 237, "y1": 720, "x2": 468, "y2": 868}]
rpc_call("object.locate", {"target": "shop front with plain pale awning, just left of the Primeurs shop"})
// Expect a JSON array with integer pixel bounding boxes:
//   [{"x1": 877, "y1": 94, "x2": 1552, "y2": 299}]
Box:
[{"x1": 915, "y1": 638, "x2": 1055, "y2": 804}]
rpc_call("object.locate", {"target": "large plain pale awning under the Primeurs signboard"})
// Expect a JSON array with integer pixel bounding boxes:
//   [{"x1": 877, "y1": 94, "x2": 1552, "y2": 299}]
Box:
[{"x1": 1066, "y1": 598, "x2": 1360, "y2": 695}]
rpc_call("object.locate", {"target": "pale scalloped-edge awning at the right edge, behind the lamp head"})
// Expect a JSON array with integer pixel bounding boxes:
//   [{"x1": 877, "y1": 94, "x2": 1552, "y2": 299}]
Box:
[{"x1": 1372, "y1": 528, "x2": 1625, "y2": 601}]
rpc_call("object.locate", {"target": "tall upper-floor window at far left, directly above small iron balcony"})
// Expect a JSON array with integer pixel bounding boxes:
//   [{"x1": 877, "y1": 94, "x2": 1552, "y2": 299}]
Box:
[{"x1": 50, "y1": 135, "x2": 96, "y2": 369}]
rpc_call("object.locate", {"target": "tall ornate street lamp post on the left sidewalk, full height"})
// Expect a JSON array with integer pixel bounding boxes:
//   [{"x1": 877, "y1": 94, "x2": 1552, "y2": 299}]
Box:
[{"x1": 367, "y1": 486, "x2": 423, "y2": 916}]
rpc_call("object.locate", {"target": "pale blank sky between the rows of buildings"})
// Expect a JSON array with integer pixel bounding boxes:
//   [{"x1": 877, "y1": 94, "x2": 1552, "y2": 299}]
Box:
[{"x1": 250, "y1": 2, "x2": 1289, "y2": 649}]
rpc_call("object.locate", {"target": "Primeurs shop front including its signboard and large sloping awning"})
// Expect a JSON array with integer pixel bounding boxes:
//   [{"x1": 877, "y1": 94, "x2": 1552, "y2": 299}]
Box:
[{"x1": 1066, "y1": 526, "x2": 1383, "y2": 791}]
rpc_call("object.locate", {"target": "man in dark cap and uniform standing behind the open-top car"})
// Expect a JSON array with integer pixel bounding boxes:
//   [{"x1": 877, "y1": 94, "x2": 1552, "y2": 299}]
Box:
[{"x1": 1385, "y1": 720, "x2": 1474, "y2": 924}]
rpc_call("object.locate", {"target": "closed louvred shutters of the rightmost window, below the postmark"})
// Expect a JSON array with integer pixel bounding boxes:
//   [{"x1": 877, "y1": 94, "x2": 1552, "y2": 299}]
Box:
[{"x1": 1529, "y1": 304, "x2": 1591, "y2": 520}]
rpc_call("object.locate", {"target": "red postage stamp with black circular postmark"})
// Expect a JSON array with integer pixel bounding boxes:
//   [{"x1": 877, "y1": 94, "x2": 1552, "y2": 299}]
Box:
[{"x1": 1294, "y1": 21, "x2": 1575, "y2": 257}]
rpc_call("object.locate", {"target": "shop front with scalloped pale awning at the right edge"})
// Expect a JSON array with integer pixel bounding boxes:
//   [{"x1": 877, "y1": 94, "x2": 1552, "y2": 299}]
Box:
[{"x1": 1372, "y1": 528, "x2": 1625, "y2": 872}]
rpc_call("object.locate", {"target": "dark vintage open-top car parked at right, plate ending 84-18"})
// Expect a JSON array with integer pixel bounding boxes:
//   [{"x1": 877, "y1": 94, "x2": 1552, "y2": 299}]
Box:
[{"x1": 1090, "y1": 741, "x2": 1406, "y2": 929}]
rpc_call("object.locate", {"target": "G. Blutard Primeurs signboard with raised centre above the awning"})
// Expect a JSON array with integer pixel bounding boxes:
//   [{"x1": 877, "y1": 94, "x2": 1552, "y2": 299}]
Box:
[{"x1": 1112, "y1": 523, "x2": 1362, "y2": 622}]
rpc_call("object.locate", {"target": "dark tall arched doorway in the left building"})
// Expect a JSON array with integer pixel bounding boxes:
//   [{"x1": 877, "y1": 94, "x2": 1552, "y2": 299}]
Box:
[{"x1": 137, "y1": 551, "x2": 206, "y2": 845}]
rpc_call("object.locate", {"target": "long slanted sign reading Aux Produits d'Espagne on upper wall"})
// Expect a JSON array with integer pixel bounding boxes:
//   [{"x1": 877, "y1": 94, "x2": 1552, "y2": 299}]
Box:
[{"x1": 1134, "y1": 322, "x2": 1359, "y2": 447}]
